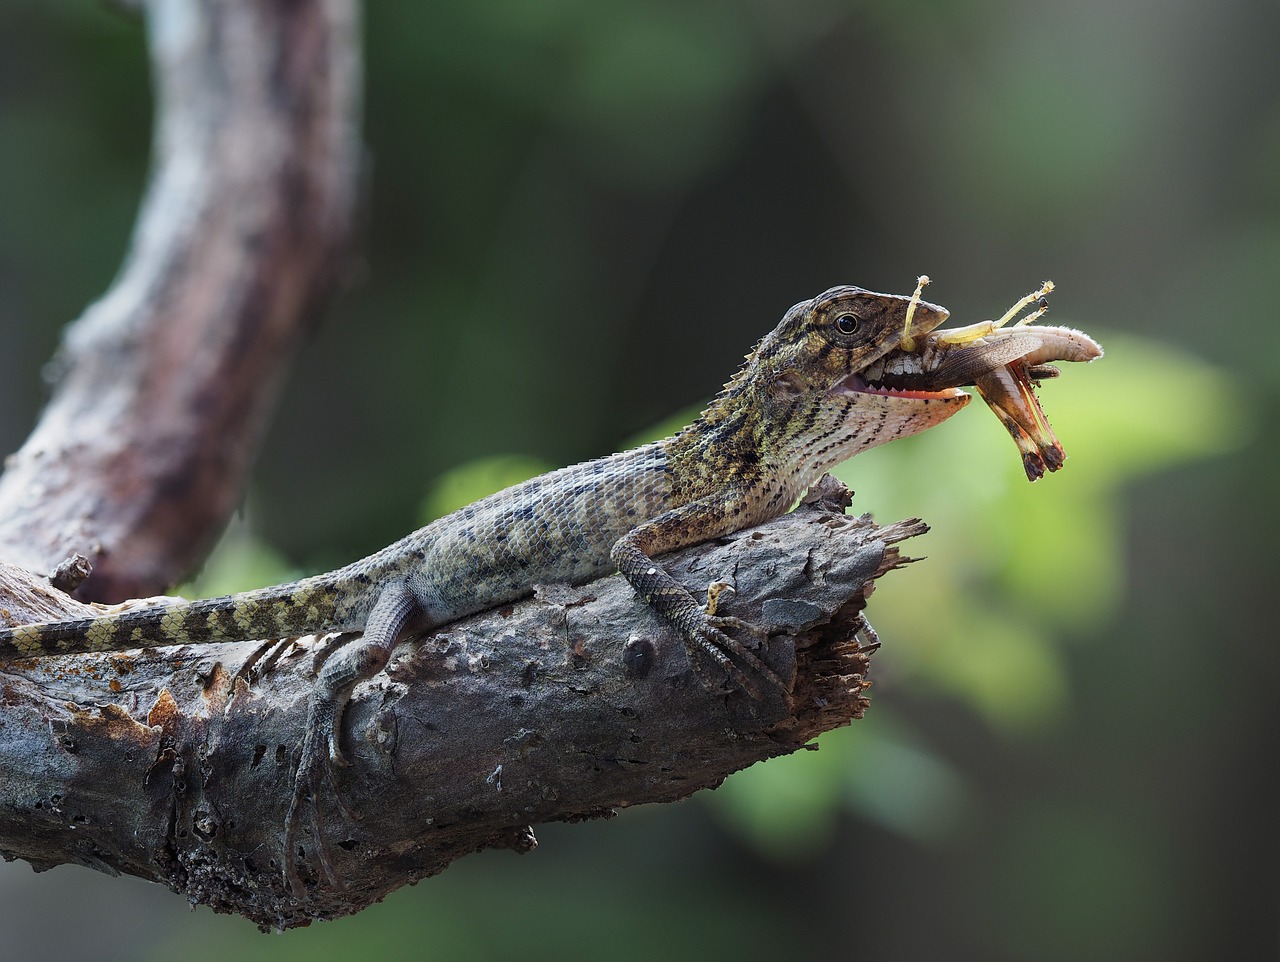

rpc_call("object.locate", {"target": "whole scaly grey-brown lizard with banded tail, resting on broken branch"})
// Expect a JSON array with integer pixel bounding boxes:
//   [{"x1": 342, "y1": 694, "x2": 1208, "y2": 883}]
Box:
[{"x1": 0, "y1": 285, "x2": 1085, "y2": 890}]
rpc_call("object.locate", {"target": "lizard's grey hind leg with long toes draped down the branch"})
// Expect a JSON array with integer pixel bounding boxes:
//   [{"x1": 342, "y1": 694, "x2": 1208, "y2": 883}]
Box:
[{"x1": 284, "y1": 582, "x2": 422, "y2": 895}]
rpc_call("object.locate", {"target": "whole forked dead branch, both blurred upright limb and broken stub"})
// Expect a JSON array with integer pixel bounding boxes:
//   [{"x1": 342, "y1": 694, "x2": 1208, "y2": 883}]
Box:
[{"x1": 0, "y1": 0, "x2": 923, "y2": 927}]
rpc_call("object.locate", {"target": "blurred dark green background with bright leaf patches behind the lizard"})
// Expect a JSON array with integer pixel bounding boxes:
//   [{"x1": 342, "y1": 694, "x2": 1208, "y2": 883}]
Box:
[{"x1": 0, "y1": 0, "x2": 1280, "y2": 962}]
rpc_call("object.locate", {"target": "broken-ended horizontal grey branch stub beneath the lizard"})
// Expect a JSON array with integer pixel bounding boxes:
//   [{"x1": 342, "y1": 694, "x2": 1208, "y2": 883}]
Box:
[{"x1": 0, "y1": 489, "x2": 924, "y2": 927}]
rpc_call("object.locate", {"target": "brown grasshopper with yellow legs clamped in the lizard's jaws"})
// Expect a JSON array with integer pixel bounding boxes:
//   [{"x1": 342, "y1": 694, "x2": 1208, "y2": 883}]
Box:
[{"x1": 859, "y1": 276, "x2": 1102, "y2": 481}]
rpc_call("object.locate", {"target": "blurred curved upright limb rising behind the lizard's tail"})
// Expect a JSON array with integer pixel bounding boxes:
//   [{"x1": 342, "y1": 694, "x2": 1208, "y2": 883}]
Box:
[{"x1": 0, "y1": 0, "x2": 360, "y2": 601}]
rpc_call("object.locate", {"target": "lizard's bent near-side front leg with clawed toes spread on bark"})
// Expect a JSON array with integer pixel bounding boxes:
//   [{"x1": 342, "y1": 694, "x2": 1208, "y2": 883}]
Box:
[{"x1": 609, "y1": 495, "x2": 790, "y2": 698}]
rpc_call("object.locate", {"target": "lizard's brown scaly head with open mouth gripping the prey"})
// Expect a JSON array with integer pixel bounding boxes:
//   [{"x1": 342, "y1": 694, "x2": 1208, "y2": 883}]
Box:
[{"x1": 704, "y1": 287, "x2": 969, "y2": 485}]
